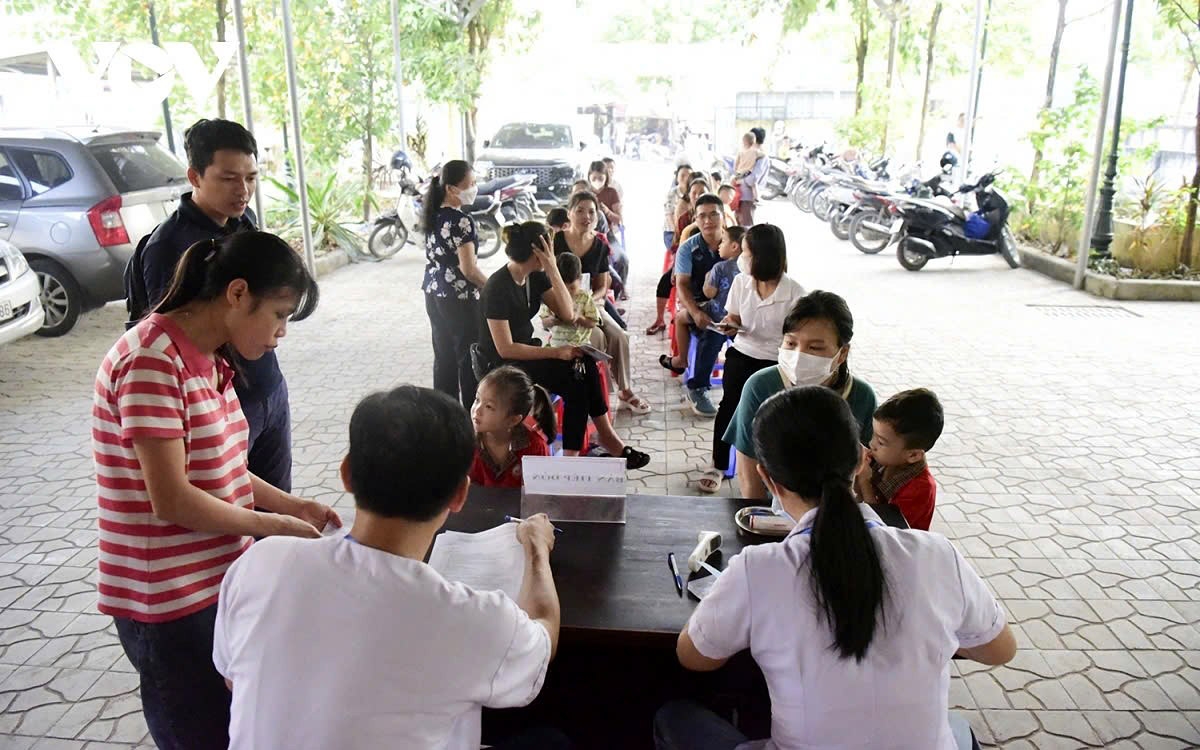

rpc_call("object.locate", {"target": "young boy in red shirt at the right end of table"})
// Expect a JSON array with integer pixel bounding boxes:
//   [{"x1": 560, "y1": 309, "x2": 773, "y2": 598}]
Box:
[{"x1": 856, "y1": 388, "x2": 946, "y2": 532}]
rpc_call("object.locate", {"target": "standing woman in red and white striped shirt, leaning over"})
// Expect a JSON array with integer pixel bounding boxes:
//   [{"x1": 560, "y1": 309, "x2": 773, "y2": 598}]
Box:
[{"x1": 92, "y1": 232, "x2": 341, "y2": 749}]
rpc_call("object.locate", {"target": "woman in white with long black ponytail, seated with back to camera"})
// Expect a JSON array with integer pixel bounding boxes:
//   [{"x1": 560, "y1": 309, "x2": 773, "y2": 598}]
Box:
[{"x1": 654, "y1": 386, "x2": 1016, "y2": 750}]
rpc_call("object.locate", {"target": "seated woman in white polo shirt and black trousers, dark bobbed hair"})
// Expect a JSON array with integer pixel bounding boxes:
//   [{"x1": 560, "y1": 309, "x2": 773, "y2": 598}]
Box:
[{"x1": 698, "y1": 224, "x2": 804, "y2": 494}]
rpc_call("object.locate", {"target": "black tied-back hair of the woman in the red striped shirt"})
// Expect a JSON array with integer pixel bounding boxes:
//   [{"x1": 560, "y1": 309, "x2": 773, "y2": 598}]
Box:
[{"x1": 155, "y1": 232, "x2": 320, "y2": 320}]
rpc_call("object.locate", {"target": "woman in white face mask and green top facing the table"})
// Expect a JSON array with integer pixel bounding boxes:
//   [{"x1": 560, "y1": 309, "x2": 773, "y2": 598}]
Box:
[{"x1": 725, "y1": 290, "x2": 877, "y2": 499}]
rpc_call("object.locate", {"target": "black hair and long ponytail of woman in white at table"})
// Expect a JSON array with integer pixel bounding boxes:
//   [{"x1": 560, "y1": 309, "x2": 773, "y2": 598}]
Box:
[{"x1": 754, "y1": 386, "x2": 887, "y2": 661}]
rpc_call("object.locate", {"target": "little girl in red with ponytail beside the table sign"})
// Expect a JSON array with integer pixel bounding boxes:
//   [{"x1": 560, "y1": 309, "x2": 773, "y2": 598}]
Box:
[{"x1": 469, "y1": 366, "x2": 558, "y2": 487}]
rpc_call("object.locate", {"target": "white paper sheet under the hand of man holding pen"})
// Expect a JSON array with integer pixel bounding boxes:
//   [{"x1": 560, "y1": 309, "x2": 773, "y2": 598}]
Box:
[{"x1": 430, "y1": 523, "x2": 526, "y2": 601}]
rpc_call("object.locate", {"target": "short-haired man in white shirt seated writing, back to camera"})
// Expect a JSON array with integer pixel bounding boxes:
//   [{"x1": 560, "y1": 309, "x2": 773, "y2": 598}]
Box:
[{"x1": 212, "y1": 385, "x2": 565, "y2": 750}]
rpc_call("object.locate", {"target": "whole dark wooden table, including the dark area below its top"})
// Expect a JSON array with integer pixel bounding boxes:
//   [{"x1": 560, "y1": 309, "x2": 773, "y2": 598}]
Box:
[{"x1": 445, "y1": 487, "x2": 907, "y2": 750}]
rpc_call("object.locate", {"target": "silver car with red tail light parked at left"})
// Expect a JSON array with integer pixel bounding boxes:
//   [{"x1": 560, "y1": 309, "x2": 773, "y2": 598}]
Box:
[{"x1": 0, "y1": 128, "x2": 188, "y2": 336}]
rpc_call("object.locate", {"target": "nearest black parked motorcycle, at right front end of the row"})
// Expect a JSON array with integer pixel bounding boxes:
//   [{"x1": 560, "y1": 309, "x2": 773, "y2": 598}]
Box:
[{"x1": 889, "y1": 173, "x2": 1021, "y2": 271}]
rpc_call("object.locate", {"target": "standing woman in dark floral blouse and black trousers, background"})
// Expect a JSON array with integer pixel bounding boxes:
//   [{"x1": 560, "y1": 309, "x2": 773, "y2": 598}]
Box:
[{"x1": 421, "y1": 160, "x2": 487, "y2": 408}]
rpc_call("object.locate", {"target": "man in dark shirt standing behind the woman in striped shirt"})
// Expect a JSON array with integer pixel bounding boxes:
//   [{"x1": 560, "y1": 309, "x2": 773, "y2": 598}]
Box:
[{"x1": 125, "y1": 120, "x2": 292, "y2": 492}]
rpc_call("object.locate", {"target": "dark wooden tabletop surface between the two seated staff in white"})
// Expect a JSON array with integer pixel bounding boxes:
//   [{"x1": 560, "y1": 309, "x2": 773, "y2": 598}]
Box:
[{"x1": 445, "y1": 487, "x2": 907, "y2": 644}]
